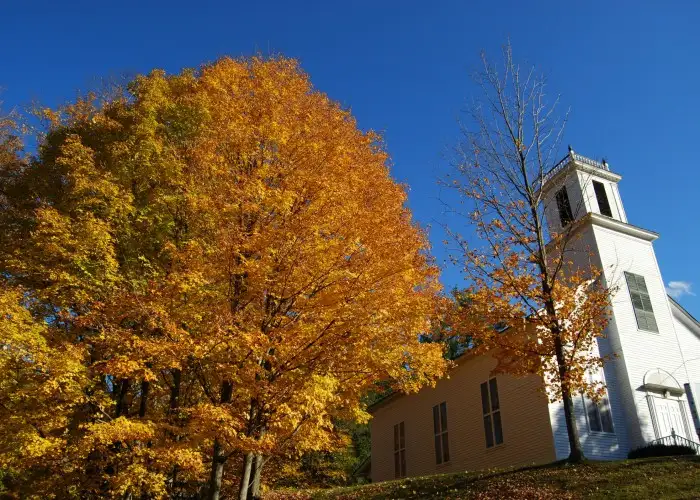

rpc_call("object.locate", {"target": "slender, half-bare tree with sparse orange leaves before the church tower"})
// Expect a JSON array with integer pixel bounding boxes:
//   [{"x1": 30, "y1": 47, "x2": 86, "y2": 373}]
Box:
[{"x1": 446, "y1": 46, "x2": 611, "y2": 461}]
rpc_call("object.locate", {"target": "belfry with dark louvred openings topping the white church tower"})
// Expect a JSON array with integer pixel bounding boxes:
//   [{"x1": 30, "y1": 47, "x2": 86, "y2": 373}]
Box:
[{"x1": 542, "y1": 146, "x2": 627, "y2": 232}]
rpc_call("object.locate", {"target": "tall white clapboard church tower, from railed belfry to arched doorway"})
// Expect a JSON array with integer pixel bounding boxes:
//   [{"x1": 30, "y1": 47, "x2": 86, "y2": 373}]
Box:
[{"x1": 541, "y1": 147, "x2": 694, "y2": 458}]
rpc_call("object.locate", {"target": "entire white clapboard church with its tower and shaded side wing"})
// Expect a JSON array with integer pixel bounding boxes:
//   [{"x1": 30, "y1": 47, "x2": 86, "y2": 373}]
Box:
[{"x1": 370, "y1": 151, "x2": 700, "y2": 481}]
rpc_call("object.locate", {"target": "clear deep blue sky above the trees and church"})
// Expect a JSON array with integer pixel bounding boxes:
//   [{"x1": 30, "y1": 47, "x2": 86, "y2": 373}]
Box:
[{"x1": 0, "y1": 0, "x2": 700, "y2": 317}]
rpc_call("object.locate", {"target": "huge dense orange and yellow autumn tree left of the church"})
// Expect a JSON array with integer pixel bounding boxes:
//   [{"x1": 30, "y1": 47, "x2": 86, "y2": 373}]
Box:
[{"x1": 0, "y1": 58, "x2": 445, "y2": 498}]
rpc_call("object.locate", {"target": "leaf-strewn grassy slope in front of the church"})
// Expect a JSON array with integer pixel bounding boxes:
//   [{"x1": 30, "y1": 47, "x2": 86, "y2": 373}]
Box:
[{"x1": 265, "y1": 457, "x2": 700, "y2": 500}]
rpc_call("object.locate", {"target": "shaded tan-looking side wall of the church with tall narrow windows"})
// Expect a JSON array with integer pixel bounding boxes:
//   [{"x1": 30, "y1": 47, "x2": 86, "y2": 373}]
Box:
[{"x1": 370, "y1": 355, "x2": 556, "y2": 481}]
